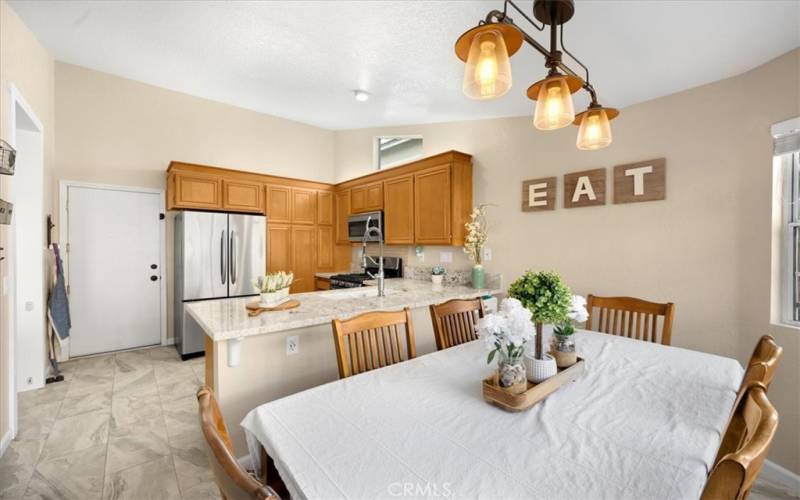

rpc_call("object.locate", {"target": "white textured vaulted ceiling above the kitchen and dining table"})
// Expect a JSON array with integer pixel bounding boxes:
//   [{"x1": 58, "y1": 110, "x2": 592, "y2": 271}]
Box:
[{"x1": 9, "y1": 0, "x2": 800, "y2": 129}]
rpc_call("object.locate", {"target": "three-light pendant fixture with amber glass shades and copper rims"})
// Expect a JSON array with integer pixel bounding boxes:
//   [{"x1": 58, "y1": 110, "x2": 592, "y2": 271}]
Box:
[{"x1": 455, "y1": 0, "x2": 619, "y2": 151}]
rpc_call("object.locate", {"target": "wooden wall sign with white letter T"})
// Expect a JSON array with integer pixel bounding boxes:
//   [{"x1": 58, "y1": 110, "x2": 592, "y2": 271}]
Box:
[{"x1": 614, "y1": 158, "x2": 667, "y2": 203}]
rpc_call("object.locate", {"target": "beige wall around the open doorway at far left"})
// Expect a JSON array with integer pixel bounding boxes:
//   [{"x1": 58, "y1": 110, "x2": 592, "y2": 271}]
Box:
[{"x1": 0, "y1": 0, "x2": 55, "y2": 439}]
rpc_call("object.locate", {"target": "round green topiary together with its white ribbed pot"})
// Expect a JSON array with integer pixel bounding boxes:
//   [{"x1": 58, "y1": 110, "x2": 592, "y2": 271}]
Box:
[{"x1": 508, "y1": 271, "x2": 572, "y2": 383}]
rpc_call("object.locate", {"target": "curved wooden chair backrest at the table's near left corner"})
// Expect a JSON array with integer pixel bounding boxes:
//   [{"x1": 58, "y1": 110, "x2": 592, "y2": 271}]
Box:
[{"x1": 197, "y1": 386, "x2": 278, "y2": 500}]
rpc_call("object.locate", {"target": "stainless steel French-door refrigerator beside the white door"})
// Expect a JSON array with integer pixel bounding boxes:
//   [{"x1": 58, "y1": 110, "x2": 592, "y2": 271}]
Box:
[{"x1": 174, "y1": 211, "x2": 267, "y2": 359}]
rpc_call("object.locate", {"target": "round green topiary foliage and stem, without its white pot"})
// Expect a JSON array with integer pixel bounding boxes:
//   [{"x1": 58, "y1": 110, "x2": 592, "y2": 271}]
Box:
[{"x1": 508, "y1": 271, "x2": 572, "y2": 359}]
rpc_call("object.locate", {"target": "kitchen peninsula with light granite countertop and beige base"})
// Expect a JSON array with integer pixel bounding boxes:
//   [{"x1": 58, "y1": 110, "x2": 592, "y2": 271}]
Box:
[{"x1": 186, "y1": 279, "x2": 500, "y2": 454}]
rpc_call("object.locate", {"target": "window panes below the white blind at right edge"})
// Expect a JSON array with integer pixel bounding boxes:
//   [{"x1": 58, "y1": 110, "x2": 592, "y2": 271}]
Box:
[{"x1": 783, "y1": 152, "x2": 800, "y2": 322}]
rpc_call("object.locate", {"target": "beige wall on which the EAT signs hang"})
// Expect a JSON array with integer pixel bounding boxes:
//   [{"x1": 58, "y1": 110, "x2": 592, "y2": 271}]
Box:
[{"x1": 336, "y1": 50, "x2": 800, "y2": 472}]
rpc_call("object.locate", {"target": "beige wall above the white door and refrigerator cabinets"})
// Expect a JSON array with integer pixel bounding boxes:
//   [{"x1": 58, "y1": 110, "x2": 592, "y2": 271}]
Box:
[{"x1": 55, "y1": 62, "x2": 334, "y2": 337}]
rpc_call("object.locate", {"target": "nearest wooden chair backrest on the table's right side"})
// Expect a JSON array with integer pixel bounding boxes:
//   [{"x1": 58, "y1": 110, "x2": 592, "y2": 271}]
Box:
[{"x1": 701, "y1": 382, "x2": 778, "y2": 500}]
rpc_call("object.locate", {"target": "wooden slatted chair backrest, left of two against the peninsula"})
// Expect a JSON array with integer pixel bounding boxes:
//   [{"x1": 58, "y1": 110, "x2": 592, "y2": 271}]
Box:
[{"x1": 332, "y1": 307, "x2": 417, "y2": 378}]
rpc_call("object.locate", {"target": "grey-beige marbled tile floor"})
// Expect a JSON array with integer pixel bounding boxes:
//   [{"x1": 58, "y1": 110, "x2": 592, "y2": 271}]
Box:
[{"x1": 0, "y1": 347, "x2": 800, "y2": 500}]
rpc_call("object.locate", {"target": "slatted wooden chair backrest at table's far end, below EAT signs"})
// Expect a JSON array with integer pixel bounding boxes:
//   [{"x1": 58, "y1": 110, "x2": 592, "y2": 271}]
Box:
[{"x1": 586, "y1": 295, "x2": 675, "y2": 345}]
